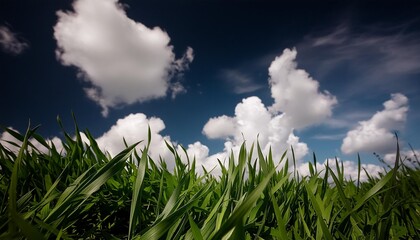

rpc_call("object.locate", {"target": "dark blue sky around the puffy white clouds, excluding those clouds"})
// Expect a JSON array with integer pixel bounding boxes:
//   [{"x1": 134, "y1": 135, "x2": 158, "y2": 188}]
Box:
[{"x1": 0, "y1": 0, "x2": 420, "y2": 174}]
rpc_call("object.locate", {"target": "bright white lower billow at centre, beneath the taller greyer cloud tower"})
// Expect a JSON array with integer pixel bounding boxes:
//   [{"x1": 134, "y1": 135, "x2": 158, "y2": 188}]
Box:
[{"x1": 203, "y1": 96, "x2": 308, "y2": 173}]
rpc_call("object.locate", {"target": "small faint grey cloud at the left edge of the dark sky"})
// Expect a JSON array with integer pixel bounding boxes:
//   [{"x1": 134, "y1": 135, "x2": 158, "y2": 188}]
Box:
[{"x1": 0, "y1": 26, "x2": 29, "y2": 55}]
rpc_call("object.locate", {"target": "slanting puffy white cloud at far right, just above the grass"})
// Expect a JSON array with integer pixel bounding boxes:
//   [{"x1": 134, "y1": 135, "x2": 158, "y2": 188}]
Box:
[{"x1": 341, "y1": 93, "x2": 408, "y2": 154}]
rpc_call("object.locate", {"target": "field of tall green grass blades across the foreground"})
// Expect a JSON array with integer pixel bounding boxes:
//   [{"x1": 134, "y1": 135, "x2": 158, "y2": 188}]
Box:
[{"x1": 0, "y1": 119, "x2": 420, "y2": 240}]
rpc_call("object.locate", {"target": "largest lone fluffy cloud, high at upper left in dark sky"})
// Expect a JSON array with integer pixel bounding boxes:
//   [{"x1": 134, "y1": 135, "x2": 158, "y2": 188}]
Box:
[{"x1": 54, "y1": 0, "x2": 194, "y2": 116}]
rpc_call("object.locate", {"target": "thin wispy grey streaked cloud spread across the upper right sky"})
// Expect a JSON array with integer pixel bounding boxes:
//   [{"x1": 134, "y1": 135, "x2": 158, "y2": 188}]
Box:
[{"x1": 297, "y1": 23, "x2": 420, "y2": 95}]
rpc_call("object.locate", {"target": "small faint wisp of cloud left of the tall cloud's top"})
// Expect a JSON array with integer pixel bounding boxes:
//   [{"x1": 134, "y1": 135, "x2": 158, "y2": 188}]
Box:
[{"x1": 222, "y1": 70, "x2": 263, "y2": 94}]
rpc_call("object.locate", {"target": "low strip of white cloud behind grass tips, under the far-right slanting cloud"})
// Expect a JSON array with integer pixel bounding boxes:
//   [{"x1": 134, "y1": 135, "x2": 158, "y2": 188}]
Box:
[{"x1": 298, "y1": 158, "x2": 384, "y2": 181}]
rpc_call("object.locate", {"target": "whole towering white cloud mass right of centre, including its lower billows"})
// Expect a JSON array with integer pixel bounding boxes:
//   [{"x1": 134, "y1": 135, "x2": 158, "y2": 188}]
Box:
[{"x1": 203, "y1": 49, "x2": 337, "y2": 172}]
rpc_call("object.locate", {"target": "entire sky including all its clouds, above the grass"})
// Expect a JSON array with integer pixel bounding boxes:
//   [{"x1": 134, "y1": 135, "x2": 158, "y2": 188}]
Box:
[{"x1": 0, "y1": 0, "x2": 420, "y2": 179}]
